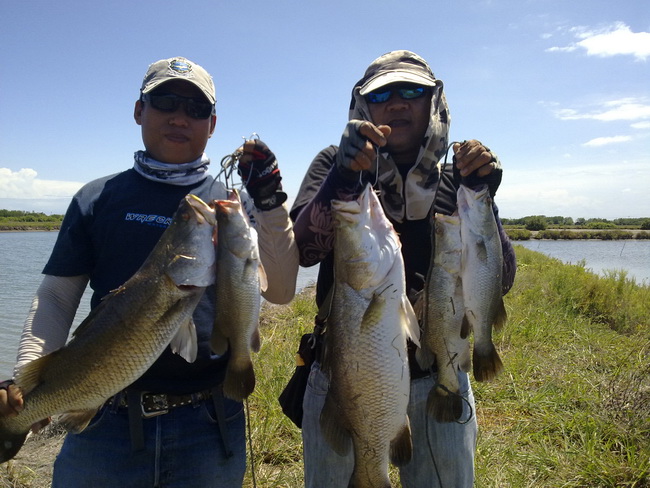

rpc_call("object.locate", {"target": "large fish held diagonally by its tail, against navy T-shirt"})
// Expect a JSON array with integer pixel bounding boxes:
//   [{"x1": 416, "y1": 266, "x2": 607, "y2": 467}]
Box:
[{"x1": 0, "y1": 195, "x2": 215, "y2": 462}]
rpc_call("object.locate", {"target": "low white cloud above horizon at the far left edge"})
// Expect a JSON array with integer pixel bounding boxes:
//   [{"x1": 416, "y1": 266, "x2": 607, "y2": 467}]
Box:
[{"x1": 0, "y1": 168, "x2": 83, "y2": 200}]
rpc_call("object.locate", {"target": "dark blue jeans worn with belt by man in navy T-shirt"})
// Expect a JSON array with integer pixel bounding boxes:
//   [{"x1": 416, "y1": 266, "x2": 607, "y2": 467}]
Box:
[{"x1": 52, "y1": 394, "x2": 246, "y2": 488}]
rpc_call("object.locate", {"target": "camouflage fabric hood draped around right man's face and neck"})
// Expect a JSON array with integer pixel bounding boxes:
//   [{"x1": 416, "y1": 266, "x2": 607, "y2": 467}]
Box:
[{"x1": 350, "y1": 80, "x2": 451, "y2": 222}]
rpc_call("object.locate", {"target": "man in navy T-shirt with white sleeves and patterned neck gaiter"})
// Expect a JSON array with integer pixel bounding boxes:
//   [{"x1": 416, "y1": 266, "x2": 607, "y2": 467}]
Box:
[{"x1": 0, "y1": 57, "x2": 298, "y2": 488}]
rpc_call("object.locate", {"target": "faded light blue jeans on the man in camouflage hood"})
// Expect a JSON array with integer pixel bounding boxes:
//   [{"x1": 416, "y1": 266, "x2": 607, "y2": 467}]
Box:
[{"x1": 302, "y1": 363, "x2": 477, "y2": 488}]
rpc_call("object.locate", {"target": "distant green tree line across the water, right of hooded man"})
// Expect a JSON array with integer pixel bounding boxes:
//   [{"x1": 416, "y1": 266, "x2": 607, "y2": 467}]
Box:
[{"x1": 501, "y1": 215, "x2": 650, "y2": 231}]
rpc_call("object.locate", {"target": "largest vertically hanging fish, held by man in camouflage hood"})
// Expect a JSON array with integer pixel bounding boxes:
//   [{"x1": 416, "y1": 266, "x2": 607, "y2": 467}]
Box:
[{"x1": 320, "y1": 186, "x2": 419, "y2": 488}]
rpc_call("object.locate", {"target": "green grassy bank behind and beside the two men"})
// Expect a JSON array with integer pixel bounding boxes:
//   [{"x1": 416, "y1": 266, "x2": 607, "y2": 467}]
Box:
[{"x1": 0, "y1": 246, "x2": 650, "y2": 488}]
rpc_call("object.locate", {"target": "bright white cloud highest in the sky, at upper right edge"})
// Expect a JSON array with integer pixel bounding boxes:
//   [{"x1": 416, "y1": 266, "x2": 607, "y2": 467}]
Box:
[{"x1": 547, "y1": 22, "x2": 650, "y2": 61}]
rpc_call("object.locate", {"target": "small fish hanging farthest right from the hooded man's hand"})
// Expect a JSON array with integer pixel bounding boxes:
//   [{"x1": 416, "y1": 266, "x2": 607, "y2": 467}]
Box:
[{"x1": 458, "y1": 185, "x2": 506, "y2": 381}]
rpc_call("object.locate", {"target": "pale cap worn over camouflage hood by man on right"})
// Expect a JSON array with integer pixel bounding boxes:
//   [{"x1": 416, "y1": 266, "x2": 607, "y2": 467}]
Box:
[{"x1": 357, "y1": 50, "x2": 436, "y2": 95}]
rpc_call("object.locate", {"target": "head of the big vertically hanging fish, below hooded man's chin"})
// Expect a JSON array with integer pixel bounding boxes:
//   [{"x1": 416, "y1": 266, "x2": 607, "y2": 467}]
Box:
[{"x1": 332, "y1": 185, "x2": 400, "y2": 290}]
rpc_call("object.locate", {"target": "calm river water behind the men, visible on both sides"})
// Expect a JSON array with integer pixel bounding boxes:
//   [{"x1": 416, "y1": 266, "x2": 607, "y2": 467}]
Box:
[{"x1": 0, "y1": 232, "x2": 650, "y2": 380}]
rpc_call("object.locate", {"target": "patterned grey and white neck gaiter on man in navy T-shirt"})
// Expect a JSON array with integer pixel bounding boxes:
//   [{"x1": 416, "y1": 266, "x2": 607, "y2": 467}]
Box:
[{"x1": 133, "y1": 151, "x2": 210, "y2": 186}]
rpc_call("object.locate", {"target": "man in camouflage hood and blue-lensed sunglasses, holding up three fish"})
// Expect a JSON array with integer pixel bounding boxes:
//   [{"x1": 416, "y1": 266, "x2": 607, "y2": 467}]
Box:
[{"x1": 290, "y1": 51, "x2": 515, "y2": 488}]
